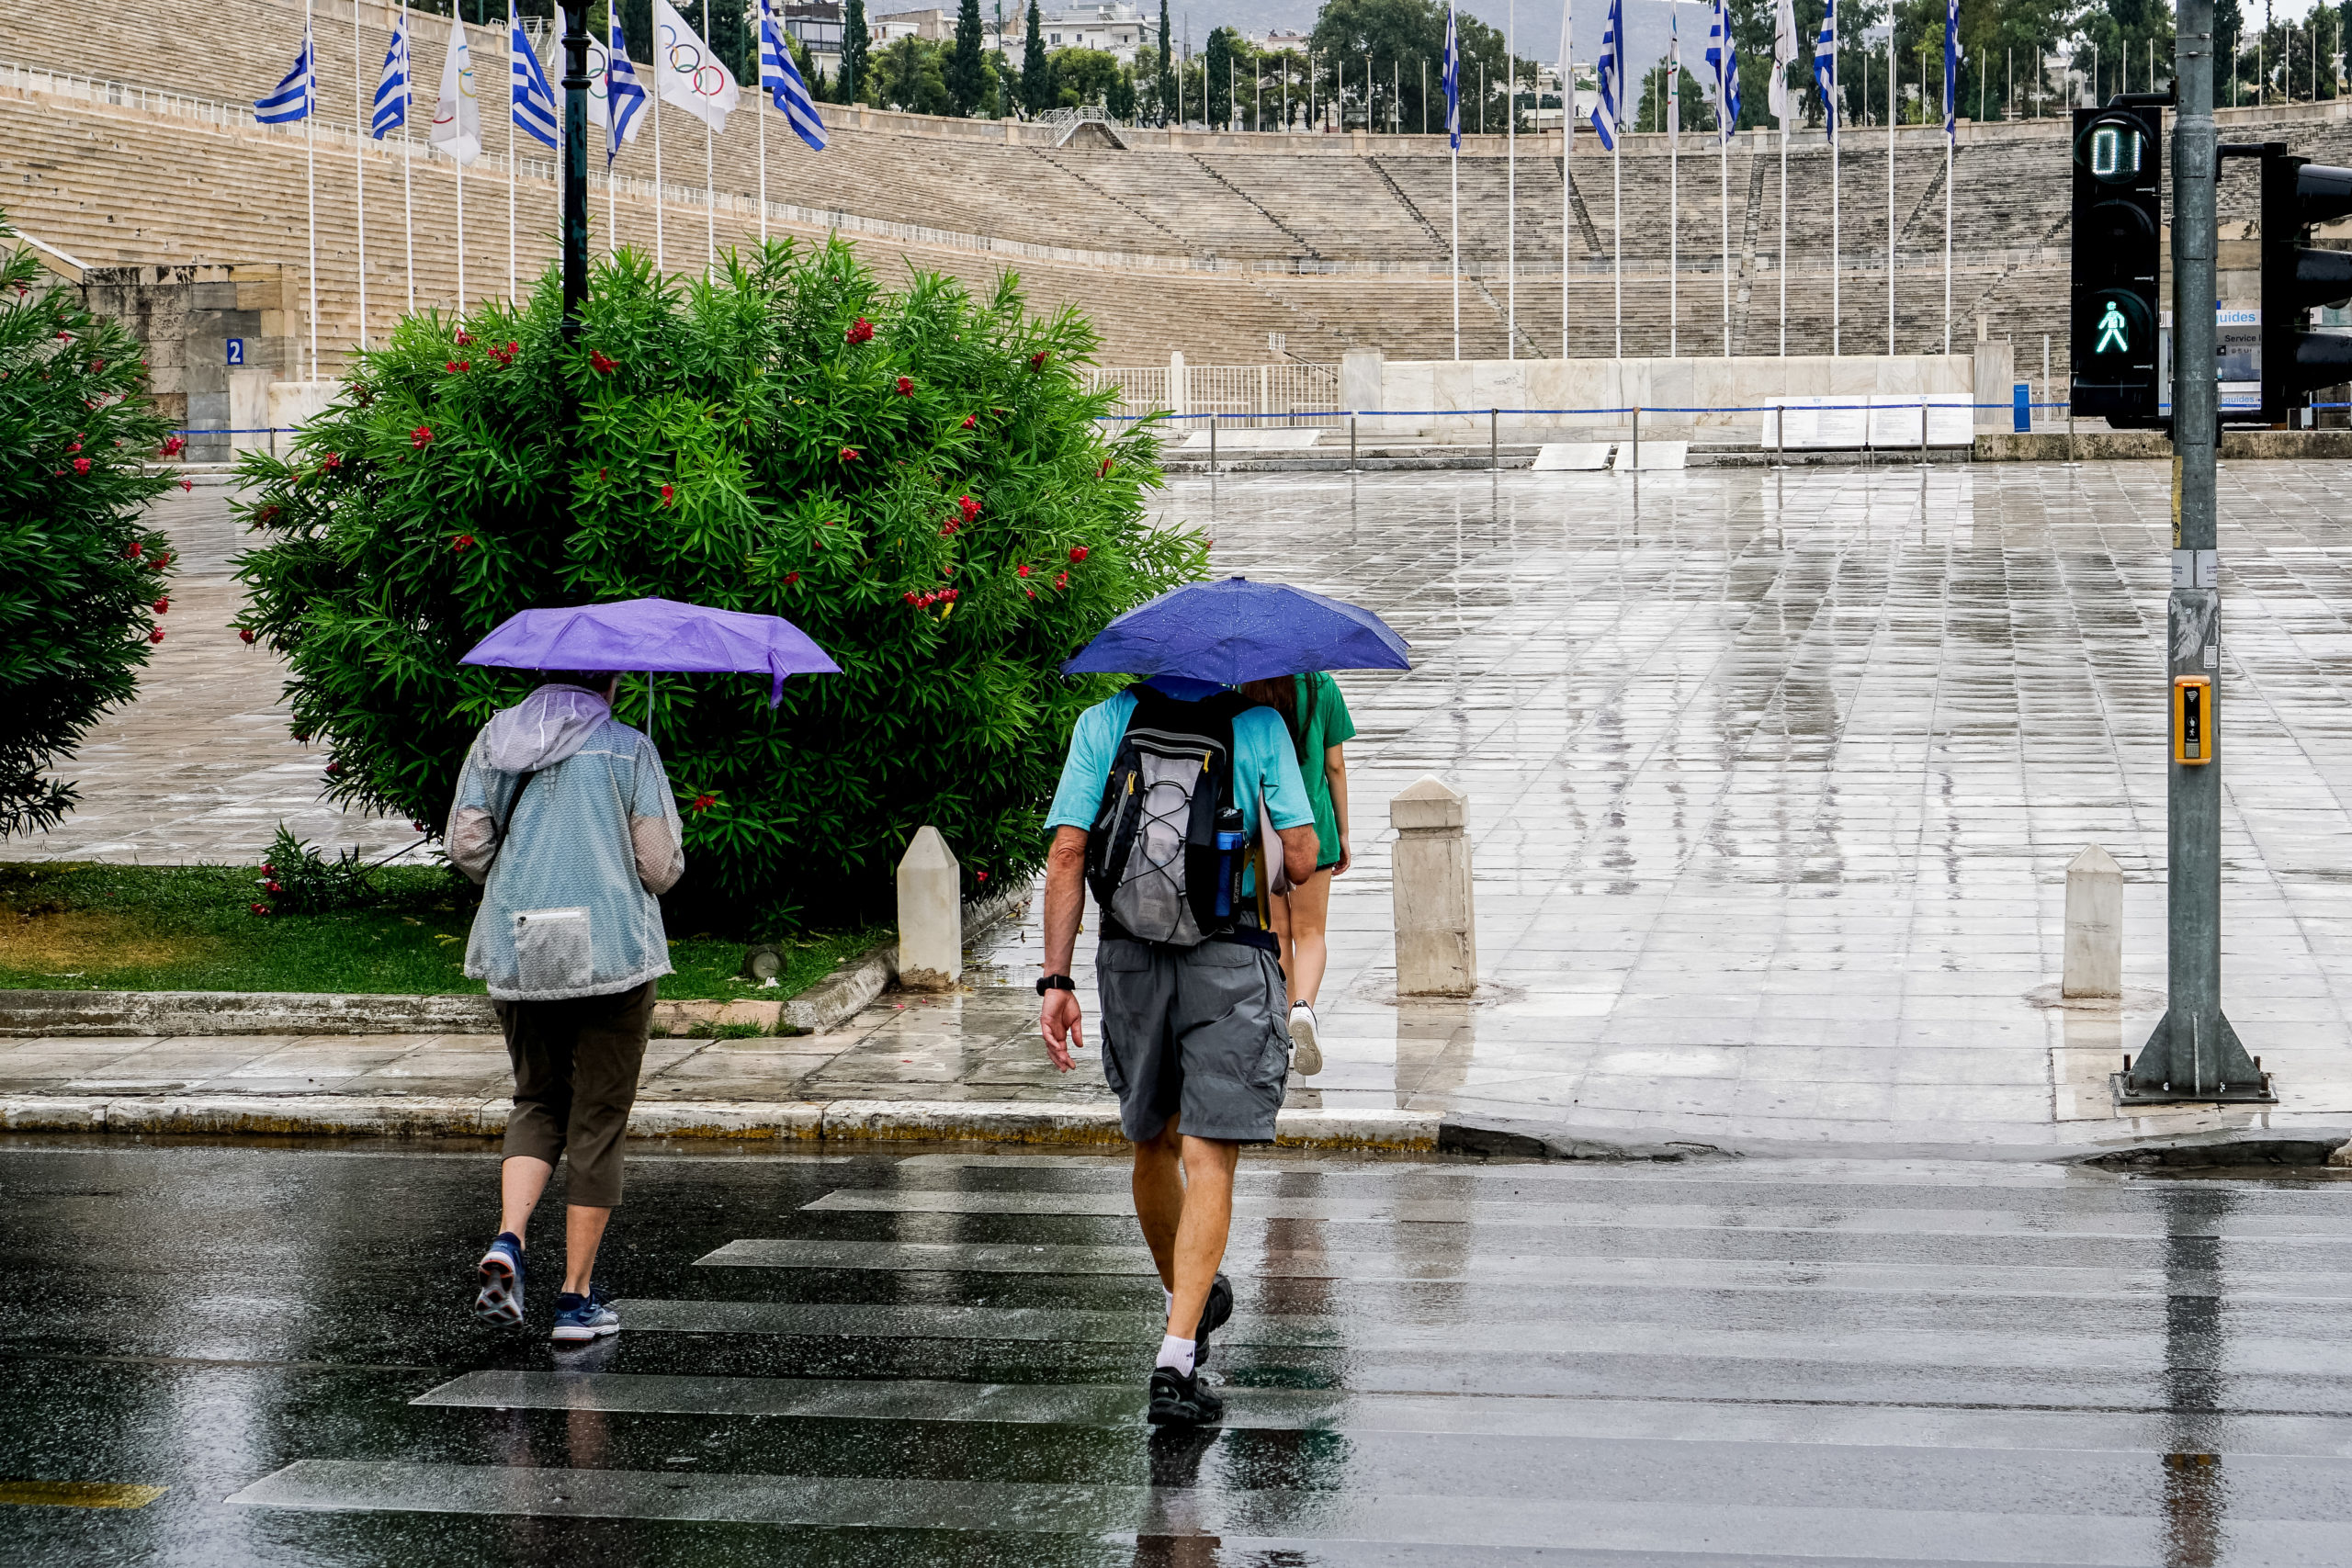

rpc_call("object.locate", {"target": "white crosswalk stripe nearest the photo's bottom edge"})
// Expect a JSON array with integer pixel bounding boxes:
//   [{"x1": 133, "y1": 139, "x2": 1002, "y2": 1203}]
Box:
[{"x1": 216, "y1": 1460, "x2": 2343, "y2": 1568}]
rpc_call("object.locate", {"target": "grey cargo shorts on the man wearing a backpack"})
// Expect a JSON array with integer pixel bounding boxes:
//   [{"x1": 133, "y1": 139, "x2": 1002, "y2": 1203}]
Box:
[{"x1": 1093, "y1": 938, "x2": 1291, "y2": 1143}]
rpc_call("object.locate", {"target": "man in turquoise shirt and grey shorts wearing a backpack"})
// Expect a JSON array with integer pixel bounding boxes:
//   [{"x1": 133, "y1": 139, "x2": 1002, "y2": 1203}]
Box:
[{"x1": 1037, "y1": 674, "x2": 1315, "y2": 1425}]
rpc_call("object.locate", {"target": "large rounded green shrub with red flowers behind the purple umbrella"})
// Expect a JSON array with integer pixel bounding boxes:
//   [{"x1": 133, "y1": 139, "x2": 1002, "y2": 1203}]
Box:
[{"x1": 240, "y1": 244, "x2": 1206, "y2": 926}]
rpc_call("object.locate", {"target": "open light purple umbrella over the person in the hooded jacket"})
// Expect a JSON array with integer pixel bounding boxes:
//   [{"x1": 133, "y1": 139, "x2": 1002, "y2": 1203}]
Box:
[{"x1": 458, "y1": 600, "x2": 842, "y2": 707}]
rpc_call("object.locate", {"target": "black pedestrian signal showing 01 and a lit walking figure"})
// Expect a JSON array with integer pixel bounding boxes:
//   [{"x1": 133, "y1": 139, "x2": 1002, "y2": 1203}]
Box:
[{"x1": 2072, "y1": 104, "x2": 2164, "y2": 428}]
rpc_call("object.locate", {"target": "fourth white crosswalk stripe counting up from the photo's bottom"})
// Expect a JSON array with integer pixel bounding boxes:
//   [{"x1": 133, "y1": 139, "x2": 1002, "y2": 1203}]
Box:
[{"x1": 696, "y1": 1236, "x2": 2352, "y2": 1304}]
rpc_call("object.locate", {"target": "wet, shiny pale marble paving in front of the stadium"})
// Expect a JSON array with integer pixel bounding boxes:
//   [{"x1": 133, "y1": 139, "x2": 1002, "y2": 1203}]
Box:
[{"x1": 17, "y1": 463, "x2": 2352, "y2": 1147}]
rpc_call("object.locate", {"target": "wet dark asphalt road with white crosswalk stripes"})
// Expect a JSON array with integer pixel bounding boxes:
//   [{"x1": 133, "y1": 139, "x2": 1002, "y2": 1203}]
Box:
[{"x1": 0, "y1": 1138, "x2": 2352, "y2": 1568}]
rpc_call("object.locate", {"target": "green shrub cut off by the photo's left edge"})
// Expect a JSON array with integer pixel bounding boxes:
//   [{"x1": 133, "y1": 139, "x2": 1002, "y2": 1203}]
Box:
[{"x1": 0, "y1": 216, "x2": 172, "y2": 837}]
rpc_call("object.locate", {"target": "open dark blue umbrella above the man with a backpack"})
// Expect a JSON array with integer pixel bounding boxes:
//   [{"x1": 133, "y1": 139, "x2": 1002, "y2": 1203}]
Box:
[{"x1": 1061, "y1": 576, "x2": 1411, "y2": 686}]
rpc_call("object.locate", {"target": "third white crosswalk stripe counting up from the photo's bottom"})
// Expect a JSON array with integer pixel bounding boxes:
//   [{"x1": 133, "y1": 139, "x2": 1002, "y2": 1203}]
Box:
[{"x1": 618, "y1": 1300, "x2": 2352, "y2": 1378}]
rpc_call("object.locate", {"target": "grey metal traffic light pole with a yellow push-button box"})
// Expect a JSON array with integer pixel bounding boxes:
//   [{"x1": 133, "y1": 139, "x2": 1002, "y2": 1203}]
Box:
[{"x1": 2114, "y1": 0, "x2": 2277, "y2": 1105}]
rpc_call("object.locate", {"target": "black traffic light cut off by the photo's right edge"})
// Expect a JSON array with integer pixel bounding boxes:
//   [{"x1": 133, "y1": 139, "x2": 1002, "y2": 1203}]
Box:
[{"x1": 2263, "y1": 141, "x2": 2352, "y2": 425}]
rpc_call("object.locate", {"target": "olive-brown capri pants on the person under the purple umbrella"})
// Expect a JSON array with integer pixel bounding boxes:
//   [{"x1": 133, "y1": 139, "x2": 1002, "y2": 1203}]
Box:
[{"x1": 492, "y1": 980, "x2": 654, "y2": 1208}]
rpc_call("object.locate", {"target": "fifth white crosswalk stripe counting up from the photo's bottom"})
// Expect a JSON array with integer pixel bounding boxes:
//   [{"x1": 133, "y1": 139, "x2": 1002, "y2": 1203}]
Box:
[{"x1": 802, "y1": 1187, "x2": 2352, "y2": 1244}]
